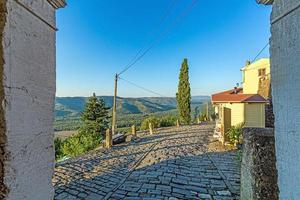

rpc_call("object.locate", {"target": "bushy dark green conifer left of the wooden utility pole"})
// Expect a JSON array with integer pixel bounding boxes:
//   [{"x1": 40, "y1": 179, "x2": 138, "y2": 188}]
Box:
[{"x1": 79, "y1": 93, "x2": 109, "y2": 135}]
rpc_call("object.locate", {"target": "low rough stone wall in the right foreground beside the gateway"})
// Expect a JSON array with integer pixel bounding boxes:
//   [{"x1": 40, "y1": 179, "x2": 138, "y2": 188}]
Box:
[{"x1": 241, "y1": 128, "x2": 278, "y2": 200}]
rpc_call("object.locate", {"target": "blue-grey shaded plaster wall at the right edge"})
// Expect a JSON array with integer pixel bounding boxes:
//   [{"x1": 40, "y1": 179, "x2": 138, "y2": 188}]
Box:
[{"x1": 270, "y1": 0, "x2": 300, "y2": 200}]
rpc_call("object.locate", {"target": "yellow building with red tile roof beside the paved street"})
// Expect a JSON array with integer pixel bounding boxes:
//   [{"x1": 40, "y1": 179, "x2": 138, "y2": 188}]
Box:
[{"x1": 212, "y1": 58, "x2": 270, "y2": 142}]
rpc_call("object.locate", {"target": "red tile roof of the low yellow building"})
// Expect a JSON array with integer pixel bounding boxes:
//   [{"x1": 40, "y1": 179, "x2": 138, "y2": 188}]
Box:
[{"x1": 211, "y1": 88, "x2": 268, "y2": 103}]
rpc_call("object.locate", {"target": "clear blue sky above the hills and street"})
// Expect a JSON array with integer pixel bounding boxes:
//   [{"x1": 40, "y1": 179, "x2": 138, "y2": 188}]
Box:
[{"x1": 57, "y1": 0, "x2": 271, "y2": 97}]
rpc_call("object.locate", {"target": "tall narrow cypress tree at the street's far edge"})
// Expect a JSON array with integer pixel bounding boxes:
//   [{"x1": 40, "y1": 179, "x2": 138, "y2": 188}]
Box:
[{"x1": 176, "y1": 58, "x2": 191, "y2": 124}]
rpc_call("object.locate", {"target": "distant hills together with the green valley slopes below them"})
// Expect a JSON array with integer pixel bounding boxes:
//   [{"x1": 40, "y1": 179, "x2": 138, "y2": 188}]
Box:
[{"x1": 54, "y1": 96, "x2": 210, "y2": 131}]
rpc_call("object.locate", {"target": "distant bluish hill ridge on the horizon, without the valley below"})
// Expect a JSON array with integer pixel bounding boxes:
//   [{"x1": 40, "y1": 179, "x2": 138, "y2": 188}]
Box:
[{"x1": 55, "y1": 96, "x2": 210, "y2": 119}]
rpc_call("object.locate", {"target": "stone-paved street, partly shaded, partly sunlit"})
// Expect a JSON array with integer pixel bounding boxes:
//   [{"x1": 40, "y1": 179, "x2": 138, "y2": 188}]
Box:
[{"x1": 53, "y1": 124, "x2": 240, "y2": 200}]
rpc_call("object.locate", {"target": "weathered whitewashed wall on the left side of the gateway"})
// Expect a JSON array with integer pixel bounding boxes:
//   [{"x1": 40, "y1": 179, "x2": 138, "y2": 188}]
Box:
[{"x1": 1, "y1": 0, "x2": 55, "y2": 200}]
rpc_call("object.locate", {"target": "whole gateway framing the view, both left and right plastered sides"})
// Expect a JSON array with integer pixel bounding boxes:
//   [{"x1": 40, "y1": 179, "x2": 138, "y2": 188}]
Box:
[{"x1": 0, "y1": 0, "x2": 300, "y2": 199}]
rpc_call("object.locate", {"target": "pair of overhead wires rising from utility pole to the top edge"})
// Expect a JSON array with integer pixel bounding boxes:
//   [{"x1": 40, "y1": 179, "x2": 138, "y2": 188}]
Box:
[{"x1": 118, "y1": 0, "x2": 199, "y2": 75}]
